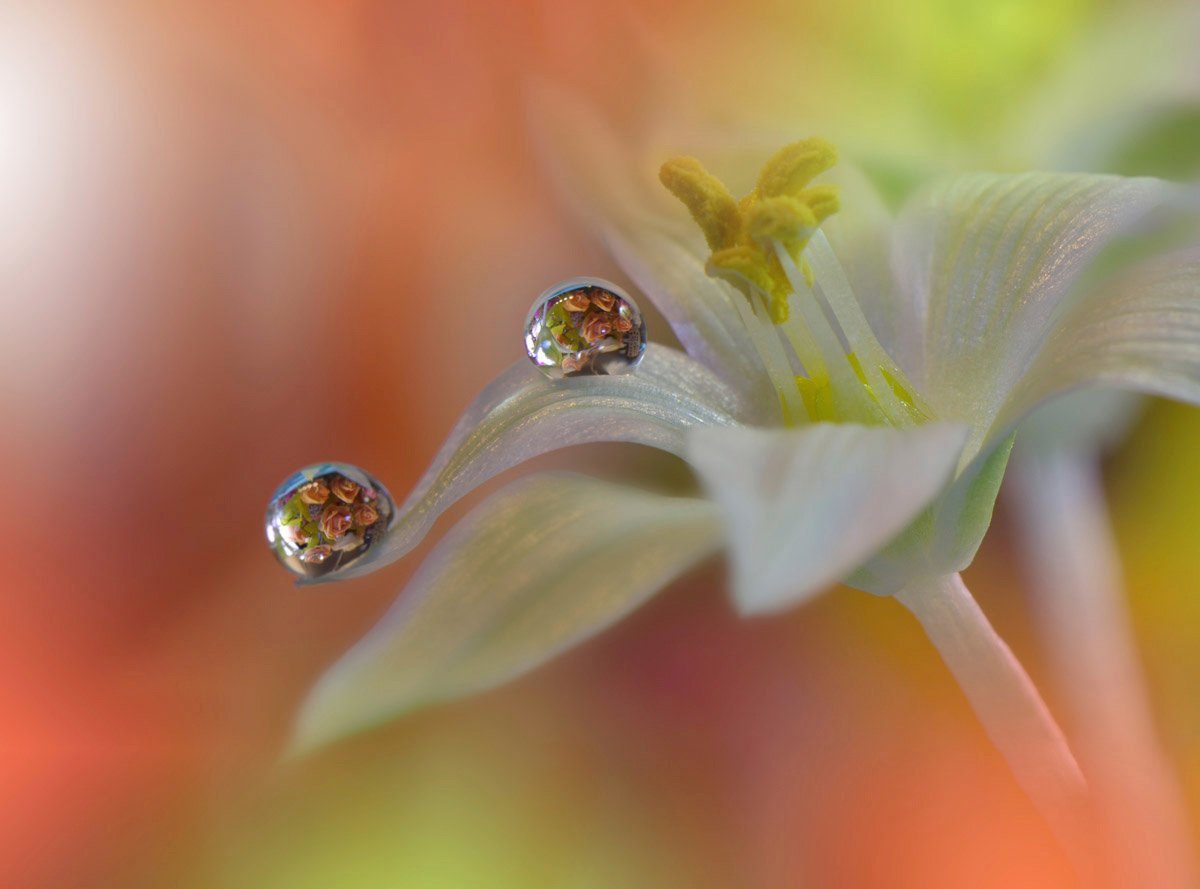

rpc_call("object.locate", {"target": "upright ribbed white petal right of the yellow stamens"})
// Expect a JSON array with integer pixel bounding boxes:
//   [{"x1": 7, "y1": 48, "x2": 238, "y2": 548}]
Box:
[{"x1": 893, "y1": 173, "x2": 1174, "y2": 452}]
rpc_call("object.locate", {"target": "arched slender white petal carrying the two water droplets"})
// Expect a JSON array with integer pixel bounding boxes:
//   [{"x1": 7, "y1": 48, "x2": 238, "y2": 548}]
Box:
[{"x1": 317, "y1": 344, "x2": 738, "y2": 582}]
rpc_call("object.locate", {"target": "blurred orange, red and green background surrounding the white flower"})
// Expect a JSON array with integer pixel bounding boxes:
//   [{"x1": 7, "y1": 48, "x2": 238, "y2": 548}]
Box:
[{"x1": 0, "y1": 0, "x2": 1200, "y2": 889}]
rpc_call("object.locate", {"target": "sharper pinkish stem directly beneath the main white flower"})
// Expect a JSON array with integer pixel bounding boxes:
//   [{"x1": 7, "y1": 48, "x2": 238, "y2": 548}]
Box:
[{"x1": 896, "y1": 573, "x2": 1092, "y2": 878}]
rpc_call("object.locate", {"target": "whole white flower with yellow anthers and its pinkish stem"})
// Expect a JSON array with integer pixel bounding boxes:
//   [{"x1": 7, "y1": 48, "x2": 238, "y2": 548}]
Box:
[{"x1": 285, "y1": 89, "x2": 1200, "y2": 859}]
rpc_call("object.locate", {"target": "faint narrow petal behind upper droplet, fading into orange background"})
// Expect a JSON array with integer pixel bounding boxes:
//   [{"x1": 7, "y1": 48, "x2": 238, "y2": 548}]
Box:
[{"x1": 530, "y1": 86, "x2": 778, "y2": 410}]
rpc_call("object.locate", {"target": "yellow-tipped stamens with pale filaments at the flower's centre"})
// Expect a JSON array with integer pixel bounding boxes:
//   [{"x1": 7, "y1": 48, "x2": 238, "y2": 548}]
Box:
[{"x1": 659, "y1": 139, "x2": 928, "y2": 426}]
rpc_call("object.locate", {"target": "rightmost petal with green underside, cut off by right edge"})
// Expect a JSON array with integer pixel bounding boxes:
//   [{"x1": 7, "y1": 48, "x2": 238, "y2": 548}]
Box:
[{"x1": 853, "y1": 229, "x2": 1200, "y2": 593}]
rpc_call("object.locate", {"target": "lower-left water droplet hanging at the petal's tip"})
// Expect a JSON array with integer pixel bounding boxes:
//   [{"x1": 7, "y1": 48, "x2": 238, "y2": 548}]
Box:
[{"x1": 266, "y1": 463, "x2": 396, "y2": 578}]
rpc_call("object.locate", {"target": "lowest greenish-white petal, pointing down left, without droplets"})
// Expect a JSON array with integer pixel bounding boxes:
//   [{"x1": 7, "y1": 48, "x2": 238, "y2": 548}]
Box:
[{"x1": 293, "y1": 474, "x2": 721, "y2": 751}]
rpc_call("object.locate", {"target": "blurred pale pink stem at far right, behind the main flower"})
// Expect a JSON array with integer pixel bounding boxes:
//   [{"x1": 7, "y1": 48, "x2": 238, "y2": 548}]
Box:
[{"x1": 1010, "y1": 450, "x2": 1200, "y2": 889}]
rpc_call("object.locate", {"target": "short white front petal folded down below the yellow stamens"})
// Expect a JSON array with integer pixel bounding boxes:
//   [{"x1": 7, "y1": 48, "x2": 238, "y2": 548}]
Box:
[{"x1": 688, "y1": 424, "x2": 966, "y2": 613}]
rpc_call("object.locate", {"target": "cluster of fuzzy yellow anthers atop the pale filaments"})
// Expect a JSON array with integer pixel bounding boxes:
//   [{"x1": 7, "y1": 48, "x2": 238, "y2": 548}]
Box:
[{"x1": 659, "y1": 139, "x2": 838, "y2": 324}]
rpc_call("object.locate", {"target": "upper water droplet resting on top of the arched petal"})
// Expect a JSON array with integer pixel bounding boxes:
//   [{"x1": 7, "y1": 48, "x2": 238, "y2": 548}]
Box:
[{"x1": 526, "y1": 278, "x2": 646, "y2": 379}]
